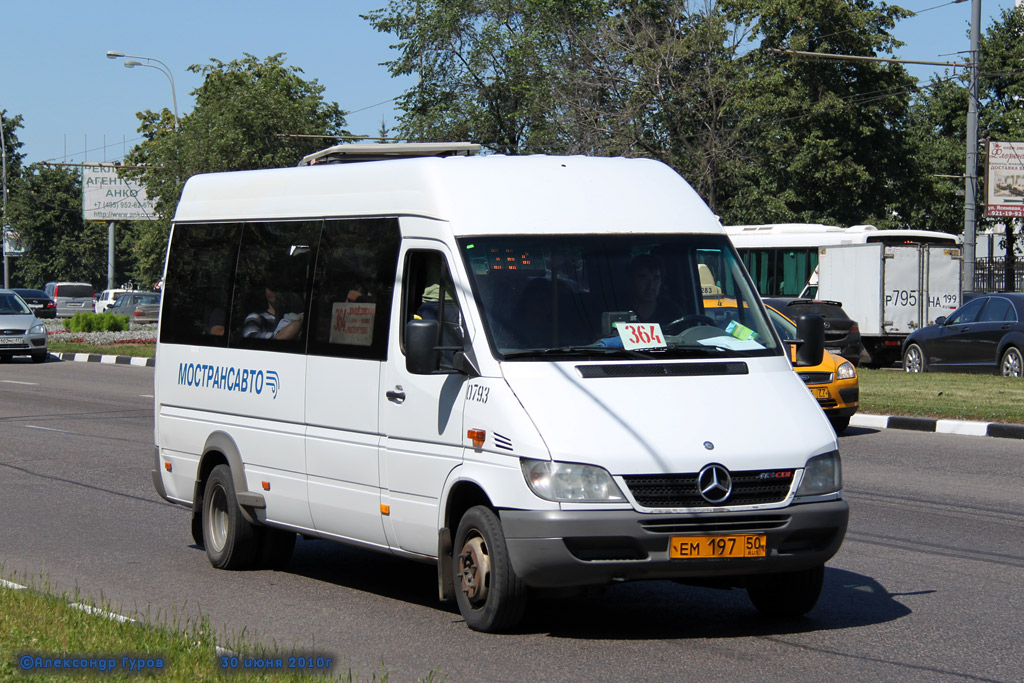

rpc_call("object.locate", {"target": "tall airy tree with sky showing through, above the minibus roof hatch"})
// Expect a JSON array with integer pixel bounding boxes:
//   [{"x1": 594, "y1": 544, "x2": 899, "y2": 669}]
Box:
[{"x1": 364, "y1": 0, "x2": 607, "y2": 155}]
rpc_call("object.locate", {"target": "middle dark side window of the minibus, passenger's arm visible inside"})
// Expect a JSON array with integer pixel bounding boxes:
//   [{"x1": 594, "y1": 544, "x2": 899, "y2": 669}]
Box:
[{"x1": 228, "y1": 221, "x2": 321, "y2": 353}]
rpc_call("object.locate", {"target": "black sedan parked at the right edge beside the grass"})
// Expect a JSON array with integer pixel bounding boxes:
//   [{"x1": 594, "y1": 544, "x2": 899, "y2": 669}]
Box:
[{"x1": 903, "y1": 294, "x2": 1024, "y2": 377}]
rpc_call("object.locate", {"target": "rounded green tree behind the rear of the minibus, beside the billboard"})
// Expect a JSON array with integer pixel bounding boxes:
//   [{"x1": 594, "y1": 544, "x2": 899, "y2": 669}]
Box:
[{"x1": 122, "y1": 53, "x2": 348, "y2": 282}]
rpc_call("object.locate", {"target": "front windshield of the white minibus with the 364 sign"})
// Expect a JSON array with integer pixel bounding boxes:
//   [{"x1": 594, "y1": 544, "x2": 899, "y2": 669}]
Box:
[{"x1": 460, "y1": 233, "x2": 780, "y2": 359}]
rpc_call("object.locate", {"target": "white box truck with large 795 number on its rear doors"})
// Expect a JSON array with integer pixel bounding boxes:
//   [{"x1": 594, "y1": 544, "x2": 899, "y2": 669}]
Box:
[{"x1": 804, "y1": 244, "x2": 963, "y2": 367}]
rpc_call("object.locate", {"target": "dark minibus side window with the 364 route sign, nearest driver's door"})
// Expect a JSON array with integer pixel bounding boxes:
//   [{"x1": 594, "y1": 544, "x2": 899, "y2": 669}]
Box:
[{"x1": 309, "y1": 218, "x2": 401, "y2": 360}]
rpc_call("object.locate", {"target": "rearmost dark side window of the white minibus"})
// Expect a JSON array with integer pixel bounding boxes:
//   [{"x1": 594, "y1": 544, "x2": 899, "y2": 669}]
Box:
[{"x1": 160, "y1": 223, "x2": 242, "y2": 346}]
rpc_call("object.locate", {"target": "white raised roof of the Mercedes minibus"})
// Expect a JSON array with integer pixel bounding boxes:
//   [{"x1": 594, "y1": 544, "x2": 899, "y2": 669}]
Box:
[{"x1": 174, "y1": 155, "x2": 723, "y2": 236}]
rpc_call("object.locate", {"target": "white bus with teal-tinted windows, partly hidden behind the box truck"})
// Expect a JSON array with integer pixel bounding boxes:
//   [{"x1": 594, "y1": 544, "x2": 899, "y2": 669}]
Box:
[{"x1": 725, "y1": 223, "x2": 959, "y2": 297}]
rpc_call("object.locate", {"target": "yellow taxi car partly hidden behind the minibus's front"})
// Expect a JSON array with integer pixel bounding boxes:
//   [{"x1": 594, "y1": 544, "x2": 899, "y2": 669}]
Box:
[{"x1": 703, "y1": 296, "x2": 860, "y2": 434}]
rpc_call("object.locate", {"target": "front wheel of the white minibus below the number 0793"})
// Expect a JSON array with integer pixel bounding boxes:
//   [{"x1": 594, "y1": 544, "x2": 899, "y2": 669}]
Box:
[{"x1": 452, "y1": 505, "x2": 526, "y2": 633}]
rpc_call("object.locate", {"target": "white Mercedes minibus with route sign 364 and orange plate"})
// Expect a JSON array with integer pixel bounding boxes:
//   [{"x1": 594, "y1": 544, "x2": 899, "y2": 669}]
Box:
[{"x1": 154, "y1": 144, "x2": 848, "y2": 632}]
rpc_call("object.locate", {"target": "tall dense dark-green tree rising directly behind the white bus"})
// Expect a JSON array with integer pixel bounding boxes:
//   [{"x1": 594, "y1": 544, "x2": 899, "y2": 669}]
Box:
[{"x1": 723, "y1": 0, "x2": 915, "y2": 225}]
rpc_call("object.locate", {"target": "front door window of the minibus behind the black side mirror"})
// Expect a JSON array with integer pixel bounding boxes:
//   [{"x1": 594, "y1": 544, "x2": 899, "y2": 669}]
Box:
[{"x1": 401, "y1": 251, "x2": 465, "y2": 368}]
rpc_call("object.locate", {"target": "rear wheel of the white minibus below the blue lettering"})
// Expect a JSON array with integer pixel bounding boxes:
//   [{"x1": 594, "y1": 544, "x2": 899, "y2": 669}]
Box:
[{"x1": 203, "y1": 465, "x2": 263, "y2": 569}]
